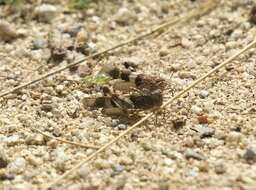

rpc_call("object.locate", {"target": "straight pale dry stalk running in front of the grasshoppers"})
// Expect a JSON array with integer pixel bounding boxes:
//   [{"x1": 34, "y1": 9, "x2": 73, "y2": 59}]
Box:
[{"x1": 44, "y1": 36, "x2": 256, "y2": 190}]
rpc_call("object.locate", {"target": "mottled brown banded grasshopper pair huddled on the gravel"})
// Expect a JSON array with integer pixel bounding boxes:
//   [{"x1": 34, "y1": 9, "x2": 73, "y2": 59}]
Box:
[{"x1": 83, "y1": 63, "x2": 166, "y2": 115}]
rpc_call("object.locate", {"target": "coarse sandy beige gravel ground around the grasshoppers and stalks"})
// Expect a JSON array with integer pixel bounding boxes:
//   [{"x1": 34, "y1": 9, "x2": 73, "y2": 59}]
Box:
[{"x1": 0, "y1": 0, "x2": 256, "y2": 190}]
